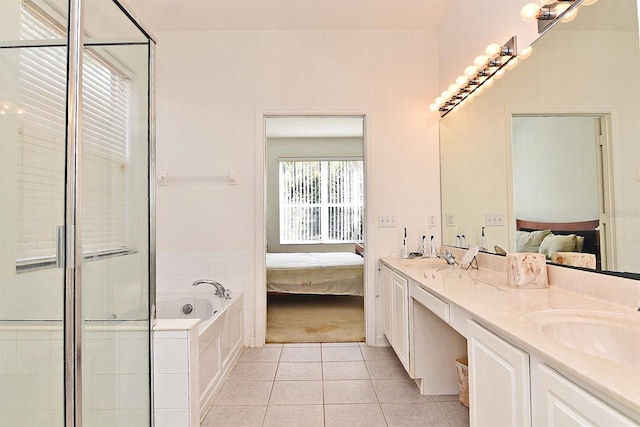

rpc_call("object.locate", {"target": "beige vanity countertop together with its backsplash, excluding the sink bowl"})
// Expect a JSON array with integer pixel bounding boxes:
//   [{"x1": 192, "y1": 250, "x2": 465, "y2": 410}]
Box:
[{"x1": 381, "y1": 254, "x2": 640, "y2": 423}]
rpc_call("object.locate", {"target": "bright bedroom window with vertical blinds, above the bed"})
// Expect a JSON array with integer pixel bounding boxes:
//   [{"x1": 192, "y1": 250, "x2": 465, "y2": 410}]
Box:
[{"x1": 280, "y1": 160, "x2": 364, "y2": 244}]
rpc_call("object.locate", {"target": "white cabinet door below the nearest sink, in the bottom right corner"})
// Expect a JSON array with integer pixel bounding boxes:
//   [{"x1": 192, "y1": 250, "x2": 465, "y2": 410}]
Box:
[{"x1": 534, "y1": 364, "x2": 637, "y2": 427}]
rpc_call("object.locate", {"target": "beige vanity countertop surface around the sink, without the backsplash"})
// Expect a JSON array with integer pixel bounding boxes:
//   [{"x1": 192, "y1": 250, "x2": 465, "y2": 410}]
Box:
[{"x1": 380, "y1": 258, "x2": 640, "y2": 419}]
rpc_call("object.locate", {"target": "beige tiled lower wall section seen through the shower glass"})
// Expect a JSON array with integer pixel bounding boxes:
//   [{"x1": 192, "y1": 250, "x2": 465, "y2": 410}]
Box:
[{"x1": 0, "y1": 321, "x2": 149, "y2": 427}]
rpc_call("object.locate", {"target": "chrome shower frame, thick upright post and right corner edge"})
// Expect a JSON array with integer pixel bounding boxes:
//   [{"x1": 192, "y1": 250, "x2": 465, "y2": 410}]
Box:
[{"x1": 58, "y1": 0, "x2": 156, "y2": 427}]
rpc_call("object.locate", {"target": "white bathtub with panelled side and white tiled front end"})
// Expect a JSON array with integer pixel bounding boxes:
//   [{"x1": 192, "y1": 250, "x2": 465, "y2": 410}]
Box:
[{"x1": 153, "y1": 287, "x2": 243, "y2": 427}]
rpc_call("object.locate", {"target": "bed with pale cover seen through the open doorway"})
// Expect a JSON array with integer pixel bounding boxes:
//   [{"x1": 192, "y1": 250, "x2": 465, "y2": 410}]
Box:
[{"x1": 267, "y1": 252, "x2": 364, "y2": 296}]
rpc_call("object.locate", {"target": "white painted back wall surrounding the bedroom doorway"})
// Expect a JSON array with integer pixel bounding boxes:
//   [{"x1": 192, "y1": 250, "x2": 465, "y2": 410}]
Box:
[{"x1": 156, "y1": 31, "x2": 440, "y2": 343}]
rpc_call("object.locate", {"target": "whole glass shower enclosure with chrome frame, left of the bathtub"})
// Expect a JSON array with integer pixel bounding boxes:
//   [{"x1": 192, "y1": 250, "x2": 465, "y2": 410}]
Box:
[{"x1": 0, "y1": 0, "x2": 155, "y2": 427}]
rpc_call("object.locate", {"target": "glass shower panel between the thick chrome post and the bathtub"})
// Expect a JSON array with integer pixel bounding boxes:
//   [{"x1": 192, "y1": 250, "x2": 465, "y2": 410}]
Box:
[{"x1": 81, "y1": 0, "x2": 153, "y2": 427}]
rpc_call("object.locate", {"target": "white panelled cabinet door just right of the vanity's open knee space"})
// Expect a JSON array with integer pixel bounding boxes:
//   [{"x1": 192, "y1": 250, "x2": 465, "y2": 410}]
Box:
[{"x1": 468, "y1": 320, "x2": 531, "y2": 427}]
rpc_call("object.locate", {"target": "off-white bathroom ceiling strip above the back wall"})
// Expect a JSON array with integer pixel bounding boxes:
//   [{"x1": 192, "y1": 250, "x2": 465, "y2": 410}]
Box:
[{"x1": 126, "y1": 0, "x2": 454, "y2": 32}]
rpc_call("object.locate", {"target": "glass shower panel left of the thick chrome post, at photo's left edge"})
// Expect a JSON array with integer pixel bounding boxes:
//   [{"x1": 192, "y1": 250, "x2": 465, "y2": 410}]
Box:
[{"x1": 0, "y1": 0, "x2": 67, "y2": 427}]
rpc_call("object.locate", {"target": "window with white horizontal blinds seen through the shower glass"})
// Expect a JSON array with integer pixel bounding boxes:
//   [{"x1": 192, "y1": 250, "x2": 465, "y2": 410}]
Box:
[{"x1": 16, "y1": 2, "x2": 129, "y2": 269}]
